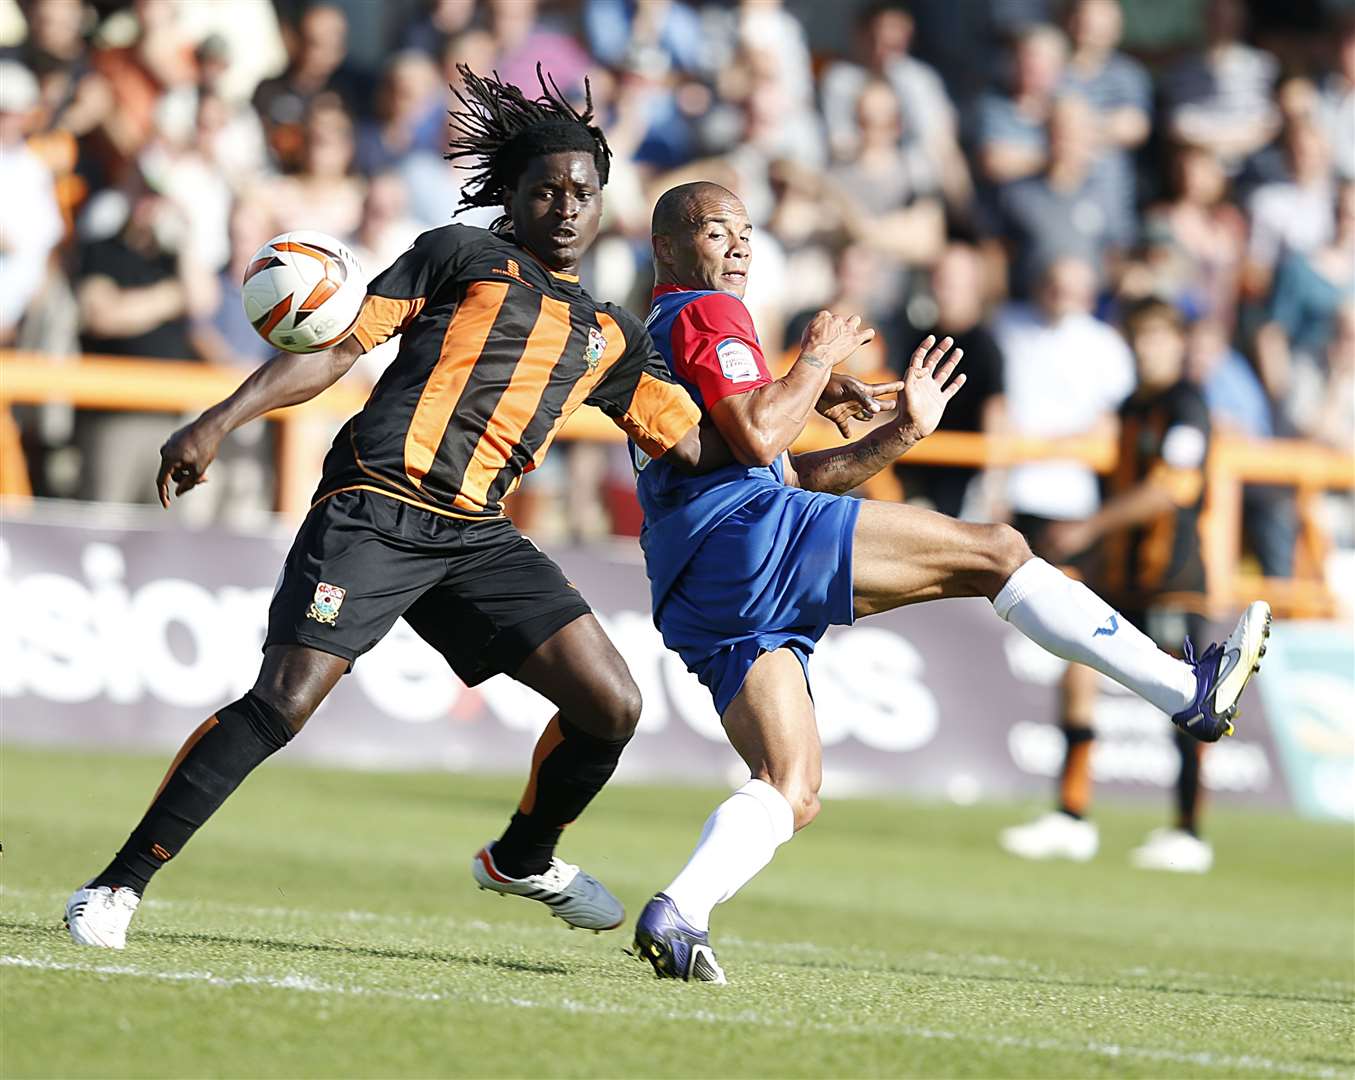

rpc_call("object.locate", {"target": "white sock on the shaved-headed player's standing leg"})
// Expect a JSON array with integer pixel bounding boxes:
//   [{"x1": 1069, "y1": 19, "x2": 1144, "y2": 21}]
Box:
[{"x1": 664, "y1": 781, "x2": 795, "y2": 930}]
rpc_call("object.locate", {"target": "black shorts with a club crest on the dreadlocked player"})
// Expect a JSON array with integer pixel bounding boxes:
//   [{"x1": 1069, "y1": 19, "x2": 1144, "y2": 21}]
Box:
[{"x1": 264, "y1": 491, "x2": 591, "y2": 686}]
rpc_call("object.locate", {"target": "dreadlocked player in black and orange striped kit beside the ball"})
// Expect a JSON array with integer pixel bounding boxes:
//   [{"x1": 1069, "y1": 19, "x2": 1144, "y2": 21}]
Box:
[{"x1": 66, "y1": 68, "x2": 729, "y2": 949}]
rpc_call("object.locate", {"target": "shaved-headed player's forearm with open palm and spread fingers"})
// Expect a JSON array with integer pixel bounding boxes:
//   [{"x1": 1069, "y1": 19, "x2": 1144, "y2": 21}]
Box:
[{"x1": 786, "y1": 336, "x2": 965, "y2": 495}]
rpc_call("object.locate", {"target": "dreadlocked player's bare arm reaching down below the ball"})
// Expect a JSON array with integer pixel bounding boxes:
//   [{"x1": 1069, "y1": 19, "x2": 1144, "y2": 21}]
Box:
[{"x1": 156, "y1": 336, "x2": 363, "y2": 508}]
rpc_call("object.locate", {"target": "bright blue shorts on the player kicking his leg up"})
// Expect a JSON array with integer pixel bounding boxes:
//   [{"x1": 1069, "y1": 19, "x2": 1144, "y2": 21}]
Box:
[{"x1": 657, "y1": 486, "x2": 860, "y2": 715}]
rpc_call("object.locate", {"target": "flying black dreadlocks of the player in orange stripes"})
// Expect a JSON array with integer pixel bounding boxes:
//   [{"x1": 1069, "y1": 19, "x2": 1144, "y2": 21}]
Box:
[{"x1": 444, "y1": 64, "x2": 611, "y2": 234}]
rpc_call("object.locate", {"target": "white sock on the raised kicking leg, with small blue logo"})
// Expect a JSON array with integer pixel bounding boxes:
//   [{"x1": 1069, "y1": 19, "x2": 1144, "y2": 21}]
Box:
[{"x1": 993, "y1": 558, "x2": 1195, "y2": 715}]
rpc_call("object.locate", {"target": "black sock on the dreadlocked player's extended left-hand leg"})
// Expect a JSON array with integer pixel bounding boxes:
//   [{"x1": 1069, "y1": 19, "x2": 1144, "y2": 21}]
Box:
[{"x1": 91, "y1": 690, "x2": 293, "y2": 893}]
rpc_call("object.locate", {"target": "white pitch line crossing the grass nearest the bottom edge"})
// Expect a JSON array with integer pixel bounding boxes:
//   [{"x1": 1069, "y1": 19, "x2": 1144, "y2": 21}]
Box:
[{"x1": 0, "y1": 955, "x2": 1347, "y2": 1080}]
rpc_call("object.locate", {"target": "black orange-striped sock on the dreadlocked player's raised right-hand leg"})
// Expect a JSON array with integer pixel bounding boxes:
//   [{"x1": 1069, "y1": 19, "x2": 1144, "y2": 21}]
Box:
[{"x1": 493, "y1": 713, "x2": 630, "y2": 878}]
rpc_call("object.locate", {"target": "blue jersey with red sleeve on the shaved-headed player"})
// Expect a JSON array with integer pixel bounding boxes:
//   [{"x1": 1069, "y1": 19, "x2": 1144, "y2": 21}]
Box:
[{"x1": 631, "y1": 285, "x2": 785, "y2": 622}]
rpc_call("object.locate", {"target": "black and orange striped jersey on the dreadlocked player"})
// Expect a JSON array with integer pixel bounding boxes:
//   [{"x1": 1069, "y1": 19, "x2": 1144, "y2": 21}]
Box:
[{"x1": 316, "y1": 225, "x2": 701, "y2": 518}]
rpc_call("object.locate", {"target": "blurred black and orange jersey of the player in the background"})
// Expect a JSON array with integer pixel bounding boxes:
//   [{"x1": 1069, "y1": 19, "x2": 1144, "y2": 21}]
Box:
[{"x1": 1104, "y1": 382, "x2": 1210, "y2": 607}]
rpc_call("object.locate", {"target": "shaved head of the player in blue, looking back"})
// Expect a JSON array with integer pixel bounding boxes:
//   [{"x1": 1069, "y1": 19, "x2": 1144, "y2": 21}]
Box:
[{"x1": 652, "y1": 180, "x2": 753, "y2": 297}]
